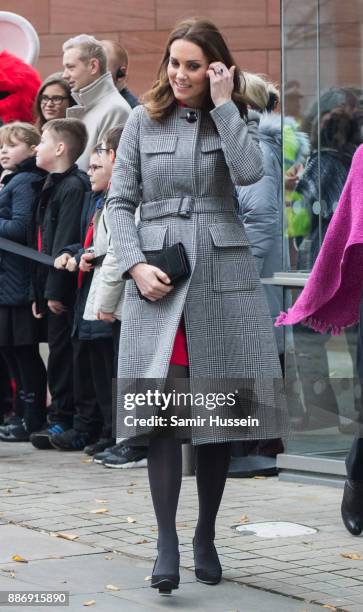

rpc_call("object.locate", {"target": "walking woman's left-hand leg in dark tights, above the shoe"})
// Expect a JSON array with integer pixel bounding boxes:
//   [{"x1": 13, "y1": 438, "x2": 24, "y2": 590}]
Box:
[{"x1": 148, "y1": 436, "x2": 182, "y2": 575}]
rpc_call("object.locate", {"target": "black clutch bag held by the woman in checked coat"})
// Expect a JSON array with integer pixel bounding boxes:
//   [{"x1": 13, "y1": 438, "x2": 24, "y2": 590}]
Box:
[{"x1": 137, "y1": 242, "x2": 190, "y2": 301}]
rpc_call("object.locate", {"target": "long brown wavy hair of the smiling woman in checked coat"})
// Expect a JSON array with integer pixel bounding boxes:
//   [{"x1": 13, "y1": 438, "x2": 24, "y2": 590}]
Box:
[{"x1": 142, "y1": 17, "x2": 247, "y2": 121}]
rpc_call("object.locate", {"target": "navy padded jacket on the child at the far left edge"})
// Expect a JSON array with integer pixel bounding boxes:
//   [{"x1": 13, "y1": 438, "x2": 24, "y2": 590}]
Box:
[{"x1": 0, "y1": 157, "x2": 46, "y2": 306}]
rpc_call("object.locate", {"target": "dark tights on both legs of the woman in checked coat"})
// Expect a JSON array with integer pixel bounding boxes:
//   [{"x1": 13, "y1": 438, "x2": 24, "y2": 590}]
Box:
[{"x1": 148, "y1": 436, "x2": 230, "y2": 574}]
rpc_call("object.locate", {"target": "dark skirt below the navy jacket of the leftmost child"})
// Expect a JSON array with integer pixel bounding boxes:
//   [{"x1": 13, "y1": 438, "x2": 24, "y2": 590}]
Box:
[{"x1": 0, "y1": 304, "x2": 46, "y2": 347}]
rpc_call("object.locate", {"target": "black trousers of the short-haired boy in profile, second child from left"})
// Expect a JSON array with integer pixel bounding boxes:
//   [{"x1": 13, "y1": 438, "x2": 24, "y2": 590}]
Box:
[{"x1": 47, "y1": 309, "x2": 74, "y2": 426}]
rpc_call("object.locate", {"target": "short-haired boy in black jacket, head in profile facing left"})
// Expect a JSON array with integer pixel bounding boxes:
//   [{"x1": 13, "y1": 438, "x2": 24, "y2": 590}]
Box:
[{"x1": 30, "y1": 119, "x2": 90, "y2": 448}]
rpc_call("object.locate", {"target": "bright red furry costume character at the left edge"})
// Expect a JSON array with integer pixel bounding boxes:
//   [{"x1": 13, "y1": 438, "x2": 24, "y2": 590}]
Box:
[{"x1": 0, "y1": 51, "x2": 41, "y2": 123}]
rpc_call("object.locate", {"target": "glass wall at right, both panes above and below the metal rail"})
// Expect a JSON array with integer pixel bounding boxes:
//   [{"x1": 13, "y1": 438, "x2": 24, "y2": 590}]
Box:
[{"x1": 282, "y1": 0, "x2": 363, "y2": 458}]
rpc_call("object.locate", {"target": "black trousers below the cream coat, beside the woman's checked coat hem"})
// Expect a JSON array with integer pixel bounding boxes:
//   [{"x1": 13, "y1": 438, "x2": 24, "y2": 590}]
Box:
[{"x1": 73, "y1": 338, "x2": 114, "y2": 438}]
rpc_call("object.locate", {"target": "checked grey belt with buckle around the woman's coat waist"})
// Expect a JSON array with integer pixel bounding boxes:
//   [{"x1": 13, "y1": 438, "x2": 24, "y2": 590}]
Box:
[{"x1": 140, "y1": 196, "x2": 237, "y2": 221}]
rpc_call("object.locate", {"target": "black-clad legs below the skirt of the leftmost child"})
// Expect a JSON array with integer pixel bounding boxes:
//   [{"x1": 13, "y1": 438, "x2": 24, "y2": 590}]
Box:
[{"x1": 0, "y1": 344, "x2": 47, "y2": 431}]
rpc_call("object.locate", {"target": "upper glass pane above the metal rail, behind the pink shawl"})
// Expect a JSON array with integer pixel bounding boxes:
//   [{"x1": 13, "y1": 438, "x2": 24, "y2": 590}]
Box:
[{"x1": 282, "y1": 0, "x2": 363, "y2": 270}]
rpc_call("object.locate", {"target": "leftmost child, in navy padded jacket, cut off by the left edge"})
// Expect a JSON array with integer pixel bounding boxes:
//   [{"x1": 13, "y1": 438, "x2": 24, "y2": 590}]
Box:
[{"x1": 0, "y1": 122, "x2": 47, "y2": 442}]
